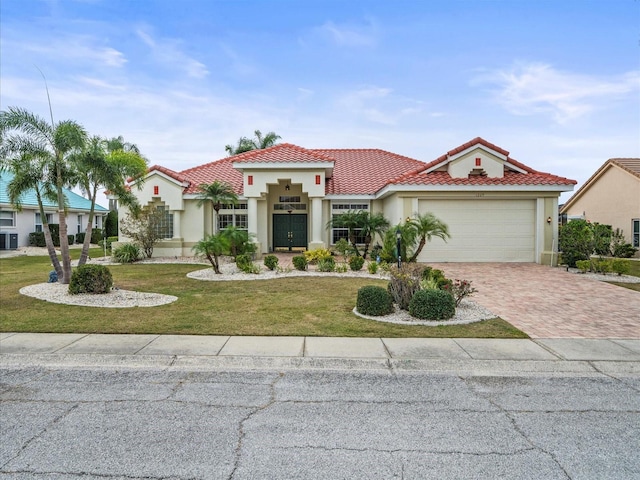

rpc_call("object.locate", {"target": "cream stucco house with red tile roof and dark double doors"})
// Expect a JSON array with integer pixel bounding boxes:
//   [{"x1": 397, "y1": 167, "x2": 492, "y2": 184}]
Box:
[{"x1": 120, "y1": 138, "x2": 576, "y2": 263}]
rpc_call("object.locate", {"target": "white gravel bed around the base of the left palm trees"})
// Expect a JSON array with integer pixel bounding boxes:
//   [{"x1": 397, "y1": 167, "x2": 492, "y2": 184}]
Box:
[{"x1": 20, "y1": 283, "x2": 178, "y2": 308}]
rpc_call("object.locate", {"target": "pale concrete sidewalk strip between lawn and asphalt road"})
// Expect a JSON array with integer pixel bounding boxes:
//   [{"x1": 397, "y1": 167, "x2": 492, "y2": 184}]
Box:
[{"x1": 0, "y1": 333, "x2": 640, "y2": 374}]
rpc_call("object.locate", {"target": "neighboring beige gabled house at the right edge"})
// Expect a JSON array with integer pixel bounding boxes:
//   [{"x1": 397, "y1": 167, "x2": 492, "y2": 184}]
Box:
[{"x1": 560, "y1": 158, "x2": 640, "y2": 253}]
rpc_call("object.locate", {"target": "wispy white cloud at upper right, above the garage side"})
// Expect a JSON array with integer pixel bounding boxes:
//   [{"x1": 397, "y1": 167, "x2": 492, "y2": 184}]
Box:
[{"x1": 472, "y1": 63, "x2": 640, "y2": 124}]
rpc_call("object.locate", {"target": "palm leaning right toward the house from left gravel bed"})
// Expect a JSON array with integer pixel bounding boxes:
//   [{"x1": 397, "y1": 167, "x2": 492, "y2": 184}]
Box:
[{"x1": 69, "y1": 136, "x2": 147, "y2": 266}]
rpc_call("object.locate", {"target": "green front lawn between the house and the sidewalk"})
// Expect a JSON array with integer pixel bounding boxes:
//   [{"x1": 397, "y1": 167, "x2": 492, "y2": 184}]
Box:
[{"x1": 0, "y1": 250, "x2": 527, "y2": 338}]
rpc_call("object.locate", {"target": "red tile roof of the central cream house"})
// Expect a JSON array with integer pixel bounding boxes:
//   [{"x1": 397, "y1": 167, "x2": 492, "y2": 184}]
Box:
[{"x1": 150, "y1": 137, "x2": 576, "y2": 195}]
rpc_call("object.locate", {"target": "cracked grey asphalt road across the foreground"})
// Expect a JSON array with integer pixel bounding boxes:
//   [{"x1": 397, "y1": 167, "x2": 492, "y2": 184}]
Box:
[{"x1": 0, "y1": 365, "x2": 640, "y2": 480}]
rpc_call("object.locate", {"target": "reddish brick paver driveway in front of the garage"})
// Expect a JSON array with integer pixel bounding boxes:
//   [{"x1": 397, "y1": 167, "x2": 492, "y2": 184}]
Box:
[{"x1": 429, "y1": 263, "x2": 640, "y2": 338}]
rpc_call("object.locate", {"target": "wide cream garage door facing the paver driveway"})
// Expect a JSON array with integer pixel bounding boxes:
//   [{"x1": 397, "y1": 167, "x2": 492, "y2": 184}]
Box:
[{"x1": 418, "y1": 199, "x2": 535, "y2": 262}]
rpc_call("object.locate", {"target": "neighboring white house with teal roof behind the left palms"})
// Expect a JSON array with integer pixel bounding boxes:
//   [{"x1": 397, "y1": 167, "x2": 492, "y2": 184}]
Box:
[{"x1": 0, "y1": 172, "x2": 109, "y2": 250}]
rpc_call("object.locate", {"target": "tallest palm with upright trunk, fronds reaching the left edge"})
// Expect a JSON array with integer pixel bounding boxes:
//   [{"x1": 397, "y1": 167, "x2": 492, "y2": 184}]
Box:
[{"x1": 0, "y1": 107, "x2": 87, "y2": 284}]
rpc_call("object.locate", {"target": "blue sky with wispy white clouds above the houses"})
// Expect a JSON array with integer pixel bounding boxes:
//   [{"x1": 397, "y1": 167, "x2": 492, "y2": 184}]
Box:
[{"x1": 0, "y1": 0, "x2": 640, "y2": 204}]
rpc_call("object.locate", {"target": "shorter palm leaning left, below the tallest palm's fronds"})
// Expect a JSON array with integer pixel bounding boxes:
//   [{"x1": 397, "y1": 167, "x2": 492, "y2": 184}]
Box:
[{"x1": 6, "y1": 155, "x2": 62, "y2": 278}]
